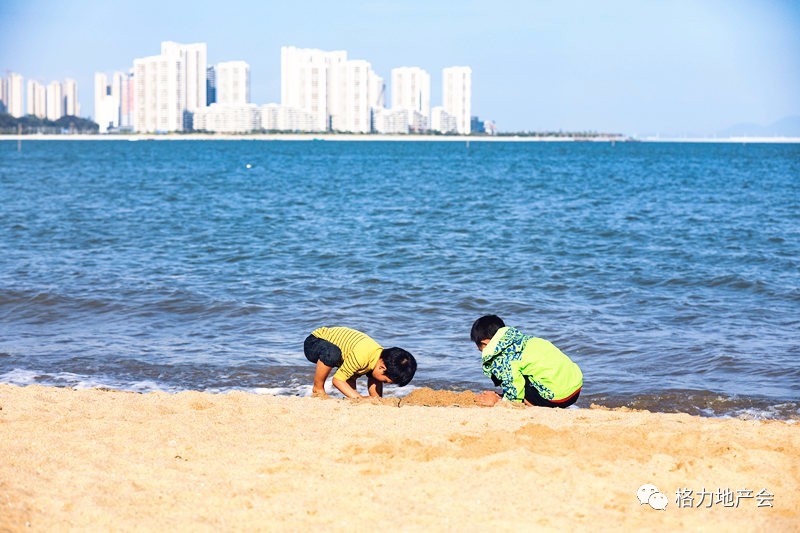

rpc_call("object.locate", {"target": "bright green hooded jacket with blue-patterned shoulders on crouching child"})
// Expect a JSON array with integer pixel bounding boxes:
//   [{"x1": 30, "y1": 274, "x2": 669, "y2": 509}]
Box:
[{"x1": 481, "y1": 327, "x2": 583, "y2": 402}]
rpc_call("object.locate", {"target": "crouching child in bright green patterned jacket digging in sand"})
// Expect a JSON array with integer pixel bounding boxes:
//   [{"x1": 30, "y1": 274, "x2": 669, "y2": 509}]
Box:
[{"x1": 470, "y1": 315, "x2": 583, "y2": 408}]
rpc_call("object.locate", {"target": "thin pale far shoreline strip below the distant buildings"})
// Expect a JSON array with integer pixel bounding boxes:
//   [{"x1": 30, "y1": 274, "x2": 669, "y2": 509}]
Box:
[{"x1": 0, "y1": 133, "x2": 800, "y2": 144}]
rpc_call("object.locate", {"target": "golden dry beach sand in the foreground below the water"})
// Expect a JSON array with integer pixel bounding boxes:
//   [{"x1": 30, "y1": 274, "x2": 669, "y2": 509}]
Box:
[{"x1": 0, "y1": 385, "x2": 800, "y2": 531}]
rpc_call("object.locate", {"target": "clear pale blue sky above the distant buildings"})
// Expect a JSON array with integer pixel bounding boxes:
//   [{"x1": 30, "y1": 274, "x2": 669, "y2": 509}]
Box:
[{"x1": 0, "y1": 0, "x2": 800, "y2": 136}]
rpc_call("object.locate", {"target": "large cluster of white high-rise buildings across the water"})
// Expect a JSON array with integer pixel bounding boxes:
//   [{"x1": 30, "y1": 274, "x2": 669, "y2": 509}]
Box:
[{"x1": 80, "y1": 41, "x2": 476, "y2": 134}]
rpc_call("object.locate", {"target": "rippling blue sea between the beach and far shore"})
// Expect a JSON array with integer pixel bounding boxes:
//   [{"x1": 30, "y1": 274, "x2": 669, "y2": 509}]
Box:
[{"x1": 0, "y1": 139, "x2": 800, "y2": 419}]
